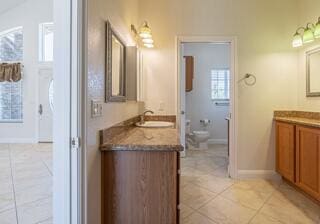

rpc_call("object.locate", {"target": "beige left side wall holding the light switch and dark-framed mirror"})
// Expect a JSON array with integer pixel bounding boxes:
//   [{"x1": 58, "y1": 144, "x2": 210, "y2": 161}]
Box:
[{"x1": 87, "y1": 0, "x2": 140, "y2": 223}]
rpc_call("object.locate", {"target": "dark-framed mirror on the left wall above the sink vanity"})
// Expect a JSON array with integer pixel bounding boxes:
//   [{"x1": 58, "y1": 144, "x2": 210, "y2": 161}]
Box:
[{"x1": 105, "y1": 21, "x2": 126, "y2": 102}]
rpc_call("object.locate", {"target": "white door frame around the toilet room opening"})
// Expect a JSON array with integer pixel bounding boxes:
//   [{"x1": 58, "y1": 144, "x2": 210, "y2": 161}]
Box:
[{"x1": 176, "y1": 36, "x2": 238, "y2": 178}]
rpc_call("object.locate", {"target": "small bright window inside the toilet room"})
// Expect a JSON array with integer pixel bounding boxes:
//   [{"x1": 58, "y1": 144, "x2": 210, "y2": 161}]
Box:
[{"x1": 211, "y1": 69, "x2": 230, "y2": 100}]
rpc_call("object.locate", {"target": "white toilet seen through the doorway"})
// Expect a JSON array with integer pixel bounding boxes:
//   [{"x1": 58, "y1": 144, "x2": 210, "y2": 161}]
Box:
[{"x1": 186, "y1": 120, "x2": 210, "y2": 149}]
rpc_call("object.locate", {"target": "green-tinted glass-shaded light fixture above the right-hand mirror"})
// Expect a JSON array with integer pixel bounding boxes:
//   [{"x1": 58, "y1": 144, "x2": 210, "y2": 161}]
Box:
[{"x1": 292, "y1": 17, "x2": 320, "y2": 47}]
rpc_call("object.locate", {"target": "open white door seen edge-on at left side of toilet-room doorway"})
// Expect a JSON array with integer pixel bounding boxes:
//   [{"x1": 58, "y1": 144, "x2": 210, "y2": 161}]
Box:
[{"x1": 178, "y1": 43, "x2": 186, "y2": 156}]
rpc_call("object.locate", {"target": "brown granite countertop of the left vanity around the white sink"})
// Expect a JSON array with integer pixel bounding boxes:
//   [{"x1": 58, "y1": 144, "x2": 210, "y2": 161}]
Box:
[{"x1": 100, "y1": 116, "x2": 183, "y2": 151}]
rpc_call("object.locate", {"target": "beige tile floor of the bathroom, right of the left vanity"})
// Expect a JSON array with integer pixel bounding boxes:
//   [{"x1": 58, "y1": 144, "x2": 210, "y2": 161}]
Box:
[{"x1": 181, "y1": 145, "x2": 320, "y2": 224}]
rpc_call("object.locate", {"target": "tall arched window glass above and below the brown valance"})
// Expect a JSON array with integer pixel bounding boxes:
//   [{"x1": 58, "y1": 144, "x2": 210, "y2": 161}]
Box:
[{"x1": 0, "y1": 27, "x2": 23, "y2": 122}]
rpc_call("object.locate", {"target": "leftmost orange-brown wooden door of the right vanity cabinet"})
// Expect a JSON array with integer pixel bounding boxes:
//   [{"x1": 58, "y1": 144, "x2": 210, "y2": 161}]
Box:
[{"x1": 276, "y1": 122, "x2": 295, "y2": 182}]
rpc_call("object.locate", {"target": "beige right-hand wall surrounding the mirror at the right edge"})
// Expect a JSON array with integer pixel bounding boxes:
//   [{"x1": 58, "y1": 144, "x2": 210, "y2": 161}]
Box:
[{"x1": 297, "y1": 0, "x2": 320, "y2": 111}]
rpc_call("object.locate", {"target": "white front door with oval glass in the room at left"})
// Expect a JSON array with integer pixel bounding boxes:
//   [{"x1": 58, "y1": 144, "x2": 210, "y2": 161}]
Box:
[{"x1": 38, "y1": 68, "x2": 53, "y2": 142}]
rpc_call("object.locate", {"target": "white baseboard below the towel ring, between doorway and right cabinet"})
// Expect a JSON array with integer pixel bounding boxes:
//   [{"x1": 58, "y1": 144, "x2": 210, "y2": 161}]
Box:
[{"x1": 237, "y1": 170, "x2": 281, "y2": 180}]
